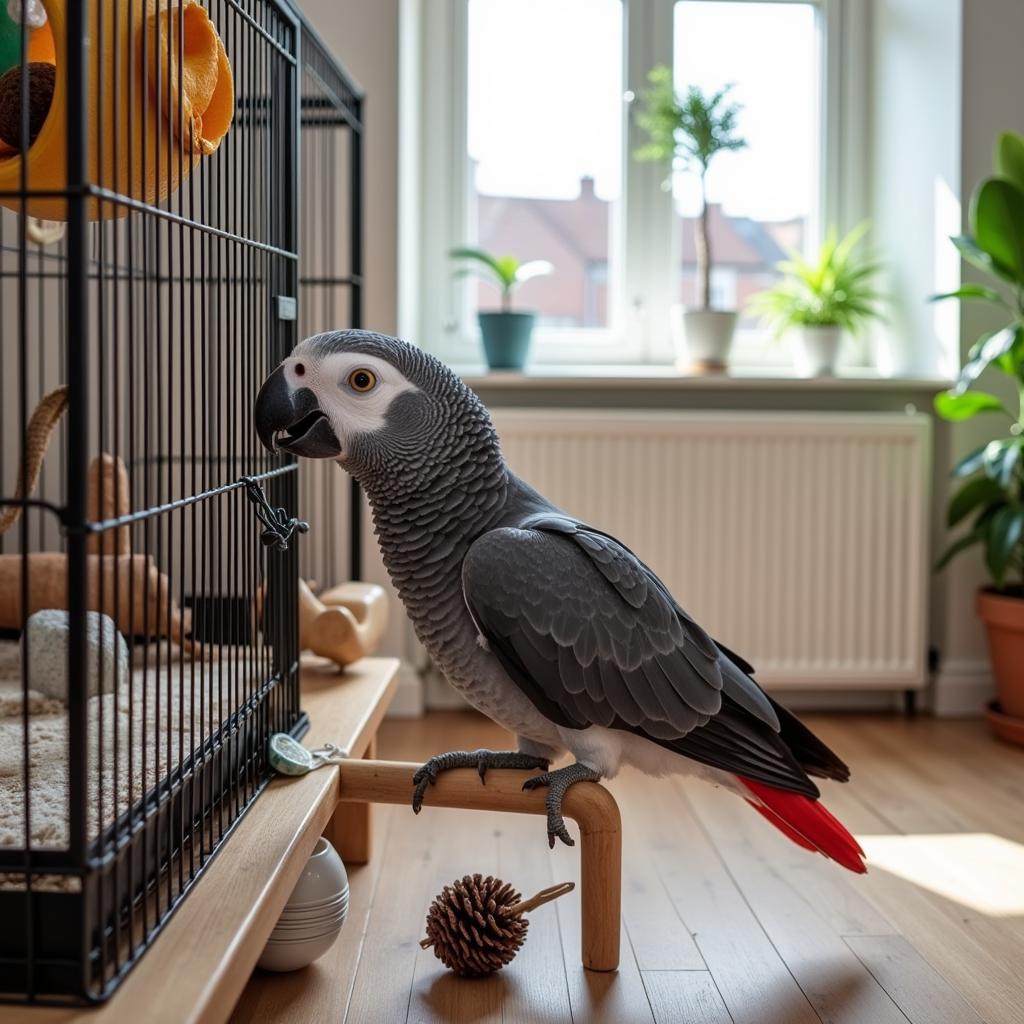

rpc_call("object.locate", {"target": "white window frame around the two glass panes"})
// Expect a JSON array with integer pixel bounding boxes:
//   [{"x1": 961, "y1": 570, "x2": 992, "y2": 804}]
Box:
[{"x1": 403, "y1": 0, "x2": 869, "y2": 367}]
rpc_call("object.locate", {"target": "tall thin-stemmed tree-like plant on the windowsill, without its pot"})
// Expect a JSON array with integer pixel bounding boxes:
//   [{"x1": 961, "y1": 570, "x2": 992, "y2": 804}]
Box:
[{"x1": 634, "y1": 65, "x2": 746, "y2": 309}]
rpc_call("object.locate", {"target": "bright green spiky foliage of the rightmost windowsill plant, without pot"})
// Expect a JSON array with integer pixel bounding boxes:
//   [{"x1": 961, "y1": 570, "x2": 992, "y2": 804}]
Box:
[{"x1": 750, "y1": 221, "x2": 882, "y2": 337}]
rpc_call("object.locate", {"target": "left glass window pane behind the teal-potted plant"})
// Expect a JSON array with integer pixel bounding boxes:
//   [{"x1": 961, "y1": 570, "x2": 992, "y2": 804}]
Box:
[{"x1": 467, "y1": 0, "x2": 623, "y2": 327}]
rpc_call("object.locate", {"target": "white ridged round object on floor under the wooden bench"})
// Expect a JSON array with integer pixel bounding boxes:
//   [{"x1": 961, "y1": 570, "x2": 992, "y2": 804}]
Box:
[{"x1": 259, "y1": 838, "x2": 348, "y2": 971}]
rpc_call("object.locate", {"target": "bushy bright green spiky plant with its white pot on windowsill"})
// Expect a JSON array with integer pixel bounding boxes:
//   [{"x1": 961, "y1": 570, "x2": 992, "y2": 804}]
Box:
[{"x1": 751, "y1": 221, "x2": 882, "y2": 377}]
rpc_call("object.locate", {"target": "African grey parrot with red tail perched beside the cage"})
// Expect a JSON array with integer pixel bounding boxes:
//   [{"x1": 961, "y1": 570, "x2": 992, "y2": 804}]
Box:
[{"x1": 255, "y1": 331, "x2": 864, "y2": 871}]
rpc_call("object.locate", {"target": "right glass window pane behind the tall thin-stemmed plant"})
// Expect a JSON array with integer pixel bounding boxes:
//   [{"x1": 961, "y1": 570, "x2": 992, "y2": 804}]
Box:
[{"x1": 673, "y1": 0, "x2": 821, "y2": 327}]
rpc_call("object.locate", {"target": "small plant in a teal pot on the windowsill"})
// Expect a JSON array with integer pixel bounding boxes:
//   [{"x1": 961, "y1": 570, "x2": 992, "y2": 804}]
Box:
[{"x1": 449, "y1": 246, "x2": 554, "y2": 370}]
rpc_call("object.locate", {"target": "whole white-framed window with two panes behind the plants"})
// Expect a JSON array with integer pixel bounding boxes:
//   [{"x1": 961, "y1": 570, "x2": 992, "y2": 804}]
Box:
[{"x1": 419, "y1": 0, "x2": 862, "y2": 365}]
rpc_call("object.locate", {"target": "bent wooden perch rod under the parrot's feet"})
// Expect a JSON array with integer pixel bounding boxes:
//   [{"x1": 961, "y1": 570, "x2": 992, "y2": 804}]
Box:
[{"x1": 339, "y1": 760, "x2": 623, "y2": 971}]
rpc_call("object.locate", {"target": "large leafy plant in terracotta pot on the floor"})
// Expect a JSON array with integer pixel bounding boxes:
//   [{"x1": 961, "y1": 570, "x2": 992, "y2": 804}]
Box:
[{"x1": 935, "y1": 133, "x2": 1024, "y2": 743}]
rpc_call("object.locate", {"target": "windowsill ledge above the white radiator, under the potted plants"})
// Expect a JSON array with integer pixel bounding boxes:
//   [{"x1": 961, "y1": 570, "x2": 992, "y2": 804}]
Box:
[{"x1": 455, "y1": 364, "x2": 953, "y2": 393}]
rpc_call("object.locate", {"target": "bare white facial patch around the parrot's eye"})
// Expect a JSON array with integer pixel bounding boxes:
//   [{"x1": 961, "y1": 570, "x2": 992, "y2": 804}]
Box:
[{"x1": 285, "y1": 342, "x2": 418, "y2": 453}]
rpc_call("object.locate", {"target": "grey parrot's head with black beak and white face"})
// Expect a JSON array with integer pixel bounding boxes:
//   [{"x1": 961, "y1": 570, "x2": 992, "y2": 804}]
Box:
[{"x1": 254, "y1": 331, "x2": 498, "y2": 487}]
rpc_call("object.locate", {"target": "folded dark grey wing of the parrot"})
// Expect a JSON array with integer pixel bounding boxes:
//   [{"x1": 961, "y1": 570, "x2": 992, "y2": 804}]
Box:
[{"x1": 463, "y1": 515, "x2": 778, "y2": 739}]
